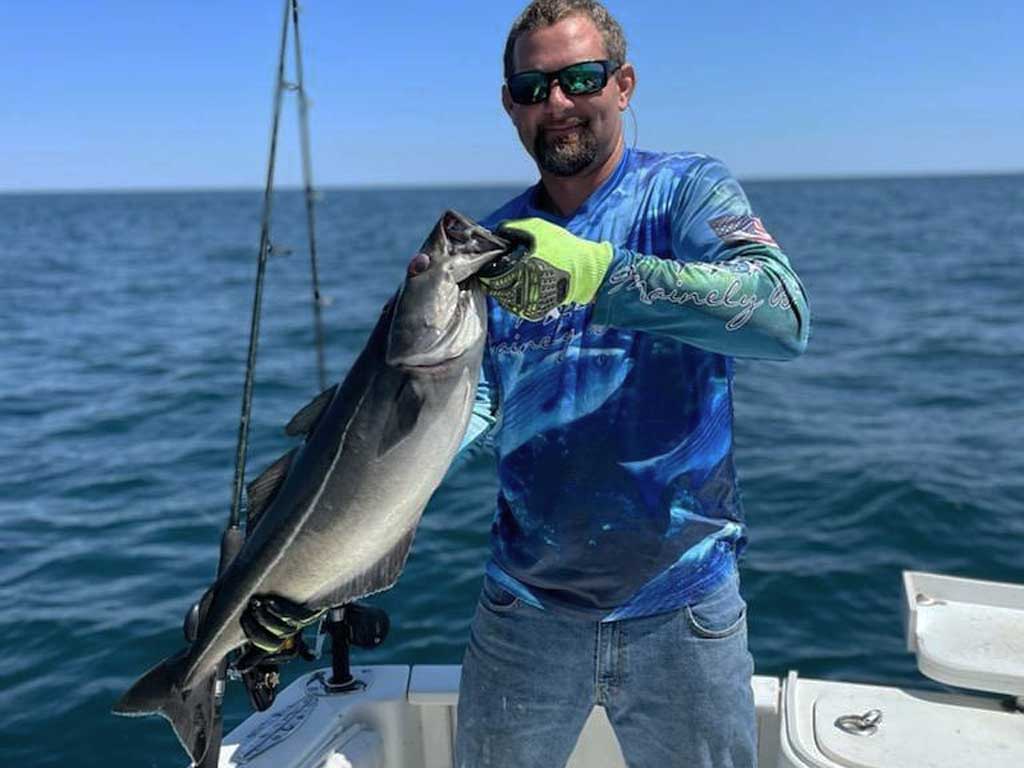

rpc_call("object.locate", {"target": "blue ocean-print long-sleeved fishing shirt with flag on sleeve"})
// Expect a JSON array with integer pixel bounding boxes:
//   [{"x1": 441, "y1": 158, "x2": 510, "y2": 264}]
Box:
[{"x1": 463, "y1": 150, "x2": 810, "y2": 621}]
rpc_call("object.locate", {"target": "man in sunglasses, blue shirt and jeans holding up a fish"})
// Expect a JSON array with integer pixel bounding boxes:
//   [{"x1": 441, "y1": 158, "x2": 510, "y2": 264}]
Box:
[{"x1": 249, "y1": 0, "x2": 809, "y2": 768}]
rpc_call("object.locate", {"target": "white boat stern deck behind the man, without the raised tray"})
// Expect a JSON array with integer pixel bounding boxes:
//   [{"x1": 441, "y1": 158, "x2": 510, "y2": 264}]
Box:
[{"x1": 219, "y1": 666, "x2": 1024, "y2": 768}]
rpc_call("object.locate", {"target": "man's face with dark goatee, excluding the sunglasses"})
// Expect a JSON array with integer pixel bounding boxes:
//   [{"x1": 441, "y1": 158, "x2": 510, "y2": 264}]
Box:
[{"x1": 502, "y1": 15, "x2": 634, "y2": 176}]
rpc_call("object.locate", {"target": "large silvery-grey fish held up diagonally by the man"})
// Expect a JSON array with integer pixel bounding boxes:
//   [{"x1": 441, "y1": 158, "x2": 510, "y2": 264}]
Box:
[{"x1": 113, "y1": 210, "x2": 513, "y2": 764}]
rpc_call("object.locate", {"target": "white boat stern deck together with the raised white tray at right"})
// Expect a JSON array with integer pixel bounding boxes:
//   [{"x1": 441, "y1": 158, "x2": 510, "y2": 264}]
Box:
[{"x1": 219, "y1": 572, "x2": 1024, "y2": 768}]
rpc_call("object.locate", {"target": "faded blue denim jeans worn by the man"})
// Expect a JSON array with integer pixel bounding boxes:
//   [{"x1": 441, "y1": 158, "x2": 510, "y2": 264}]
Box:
[{"x1": 456, "y1": 573, "x2": 757, "y2": 768}]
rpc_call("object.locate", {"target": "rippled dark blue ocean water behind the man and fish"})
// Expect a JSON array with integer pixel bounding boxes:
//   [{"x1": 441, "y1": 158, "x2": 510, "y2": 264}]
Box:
[{"x1": 0, "y1": 176, "x2": 1024, "y2": 768}]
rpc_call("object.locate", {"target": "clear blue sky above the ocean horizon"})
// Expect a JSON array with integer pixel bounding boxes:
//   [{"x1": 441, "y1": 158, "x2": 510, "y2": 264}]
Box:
[{"x1": 0, "y1": 0, "x2": 1024, "y2": 191}]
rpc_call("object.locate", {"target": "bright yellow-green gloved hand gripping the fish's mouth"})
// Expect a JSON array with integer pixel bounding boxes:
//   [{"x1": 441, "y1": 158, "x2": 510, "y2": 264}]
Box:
[{"x1": 479, "y1": 218, "x2": 614, "y2": 321}]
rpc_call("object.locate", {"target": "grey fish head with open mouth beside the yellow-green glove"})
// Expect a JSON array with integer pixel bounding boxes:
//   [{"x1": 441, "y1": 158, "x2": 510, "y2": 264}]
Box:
[{"x1": 386, "y1": 211, "x2": 513, "y2": 369}]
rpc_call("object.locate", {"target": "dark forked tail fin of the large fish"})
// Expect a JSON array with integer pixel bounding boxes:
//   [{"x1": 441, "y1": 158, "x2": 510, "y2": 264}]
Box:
[{"x1": 113, "y1": 650, "x2": 219, "y2": 765}]
